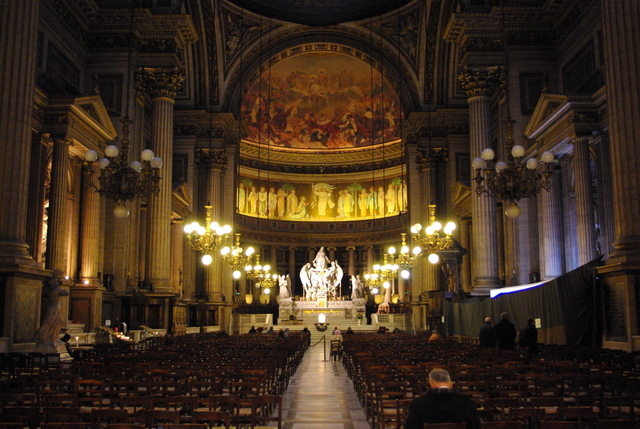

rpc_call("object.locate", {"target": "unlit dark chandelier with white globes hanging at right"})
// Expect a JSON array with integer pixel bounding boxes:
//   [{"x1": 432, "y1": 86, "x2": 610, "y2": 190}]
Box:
[{"x1": 471, "y1": 116, "x2": 555, "y2": 218}]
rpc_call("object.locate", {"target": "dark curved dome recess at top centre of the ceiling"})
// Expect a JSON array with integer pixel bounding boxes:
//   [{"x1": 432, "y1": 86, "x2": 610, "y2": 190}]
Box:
[{"x1": 229, "y1": 0, "x2": 413, "y2": 26}]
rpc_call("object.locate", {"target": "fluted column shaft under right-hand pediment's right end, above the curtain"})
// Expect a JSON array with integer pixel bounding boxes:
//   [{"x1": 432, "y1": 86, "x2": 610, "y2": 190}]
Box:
[{"x1": 573, "y1": 138, "x2": 596, "y2": 265}]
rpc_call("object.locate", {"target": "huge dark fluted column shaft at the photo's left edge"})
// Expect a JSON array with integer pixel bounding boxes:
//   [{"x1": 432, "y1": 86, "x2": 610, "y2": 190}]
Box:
[{"x1": 0, "y1": 0, "x2": 40, "y2": 264}]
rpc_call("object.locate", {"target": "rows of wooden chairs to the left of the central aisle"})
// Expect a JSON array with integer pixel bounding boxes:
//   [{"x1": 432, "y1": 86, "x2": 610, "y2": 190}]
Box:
[{"x1": 0, "y1": 334, "x2": 308, "y2": 429}]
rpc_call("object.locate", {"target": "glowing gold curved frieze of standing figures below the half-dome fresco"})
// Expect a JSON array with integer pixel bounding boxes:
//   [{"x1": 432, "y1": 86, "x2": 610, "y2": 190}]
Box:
[{"x1": 236, "y1": 176, "x2": 407, "y2": 222}]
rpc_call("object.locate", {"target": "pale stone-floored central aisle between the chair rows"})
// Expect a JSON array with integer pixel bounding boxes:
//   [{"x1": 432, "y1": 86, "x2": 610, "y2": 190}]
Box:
[{"x1": 282, "y1": 340, "x2": 371, "y2": 429}]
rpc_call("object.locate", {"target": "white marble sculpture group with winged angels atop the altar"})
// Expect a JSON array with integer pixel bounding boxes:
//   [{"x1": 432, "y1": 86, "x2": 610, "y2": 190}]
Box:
[{"x1": 300, "y1": 247, "x2": 344, "y2": 300}]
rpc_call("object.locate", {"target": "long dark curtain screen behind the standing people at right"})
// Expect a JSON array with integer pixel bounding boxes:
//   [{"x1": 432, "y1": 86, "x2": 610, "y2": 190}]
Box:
[{"x1": 443, "y1": 258, "x2": 602, "y2": 346}]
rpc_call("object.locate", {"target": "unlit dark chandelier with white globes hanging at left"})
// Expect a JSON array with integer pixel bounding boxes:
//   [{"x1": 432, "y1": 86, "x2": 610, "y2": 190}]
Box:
[{"x1": 85, "y1": 116, "x2": 162, "y2": 218}]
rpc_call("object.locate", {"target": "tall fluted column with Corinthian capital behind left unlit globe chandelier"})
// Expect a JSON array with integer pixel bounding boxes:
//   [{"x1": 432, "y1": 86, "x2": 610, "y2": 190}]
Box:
[{"x1": 136, "y1": 69, "x2": 183, "y2": 293}]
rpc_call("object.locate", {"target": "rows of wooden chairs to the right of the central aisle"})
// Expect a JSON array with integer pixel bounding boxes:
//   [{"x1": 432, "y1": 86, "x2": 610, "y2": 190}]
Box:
[{"x1": 343, "y1": 334, "x2": 640, "y2": 429}]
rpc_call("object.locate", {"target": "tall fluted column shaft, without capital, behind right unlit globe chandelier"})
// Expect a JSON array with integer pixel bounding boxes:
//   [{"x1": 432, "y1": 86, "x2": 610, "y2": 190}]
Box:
[{"x1": 469, "y1": 95, "x2": 500, "y2": 291}]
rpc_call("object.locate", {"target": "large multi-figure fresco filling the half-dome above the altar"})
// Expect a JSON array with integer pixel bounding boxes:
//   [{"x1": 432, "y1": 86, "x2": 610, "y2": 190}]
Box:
[{"x1": 242, "y1": 53, "x2": 402, "y2": 150}]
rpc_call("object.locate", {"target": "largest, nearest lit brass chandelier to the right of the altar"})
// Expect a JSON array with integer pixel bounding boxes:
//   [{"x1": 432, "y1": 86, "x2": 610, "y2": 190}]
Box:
[{"x1": 411, "y1": 204, "x2": 456, "y2": 264}]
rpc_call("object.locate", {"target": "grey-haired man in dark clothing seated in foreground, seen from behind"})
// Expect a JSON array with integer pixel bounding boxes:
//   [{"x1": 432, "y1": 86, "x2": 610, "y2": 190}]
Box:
[{"x1": 404, "y1": 368, "x2": 480, "y2": 429}]
